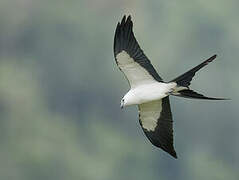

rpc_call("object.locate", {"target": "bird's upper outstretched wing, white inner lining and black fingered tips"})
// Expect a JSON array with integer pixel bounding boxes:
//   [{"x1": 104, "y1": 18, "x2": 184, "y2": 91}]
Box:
[{"x1": 114, "y1": 16, "x2": 162, "y2": 87}]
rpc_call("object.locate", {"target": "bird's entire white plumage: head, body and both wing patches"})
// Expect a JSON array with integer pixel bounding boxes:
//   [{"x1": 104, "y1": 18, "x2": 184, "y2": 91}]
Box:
[{"x1": 116, "y1": 50, "x2": 177, "y2": 131}]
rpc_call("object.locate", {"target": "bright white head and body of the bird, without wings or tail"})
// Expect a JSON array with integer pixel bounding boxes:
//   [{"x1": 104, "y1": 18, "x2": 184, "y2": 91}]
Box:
[{"x1": 124, "y1": 81, "x2": 177, "y2": 105}]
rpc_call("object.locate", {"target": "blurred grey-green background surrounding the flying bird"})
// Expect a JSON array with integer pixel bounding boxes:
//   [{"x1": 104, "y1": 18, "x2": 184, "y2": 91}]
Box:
[{"x1": 0, "y1": 0, "x2": 239, "y2": 180}]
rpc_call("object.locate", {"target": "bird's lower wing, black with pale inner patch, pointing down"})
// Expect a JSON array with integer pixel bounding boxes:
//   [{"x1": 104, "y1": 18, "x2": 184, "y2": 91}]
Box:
[{"x1": 139, "y1": 97, "x2": 177, "y2": 158}]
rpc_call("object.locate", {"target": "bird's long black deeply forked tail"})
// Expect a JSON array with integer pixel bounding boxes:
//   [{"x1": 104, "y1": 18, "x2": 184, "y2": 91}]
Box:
[{"x1": 170, "y1": 55, "x2": 228, "y2": 100}]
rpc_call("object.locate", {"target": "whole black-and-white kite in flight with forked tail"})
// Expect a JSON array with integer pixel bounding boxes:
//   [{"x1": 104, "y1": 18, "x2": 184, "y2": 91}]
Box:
[{"x1": 114, "y1": 16, "x2": 228, "y2": 158}]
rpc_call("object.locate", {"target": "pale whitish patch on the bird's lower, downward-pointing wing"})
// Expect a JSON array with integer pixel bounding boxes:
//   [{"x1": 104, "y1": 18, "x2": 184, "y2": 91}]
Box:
[{"x1": 139, "y1": 100, "x2": 162, "y2": 131}]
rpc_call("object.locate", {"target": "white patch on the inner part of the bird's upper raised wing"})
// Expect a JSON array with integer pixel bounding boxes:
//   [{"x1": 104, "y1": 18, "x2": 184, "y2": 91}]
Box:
[{"x1": 116, "y1": 51, "x2": 157, "y2": 88}]
